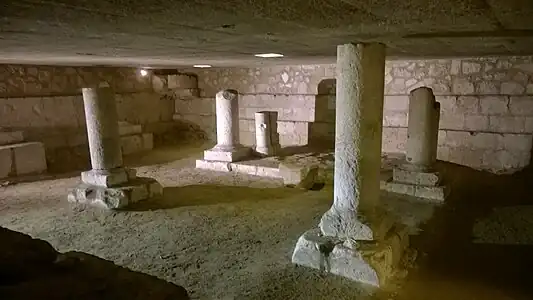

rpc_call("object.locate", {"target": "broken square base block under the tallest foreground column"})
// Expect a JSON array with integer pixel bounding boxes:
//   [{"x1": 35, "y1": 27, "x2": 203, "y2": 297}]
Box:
[{"x1": 292, "y1": 226, "x2": 409, "y2": 286}]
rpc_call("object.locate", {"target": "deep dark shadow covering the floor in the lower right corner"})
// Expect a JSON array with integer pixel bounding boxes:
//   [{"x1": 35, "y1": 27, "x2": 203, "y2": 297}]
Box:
[{"x1": 386, "y1": 164, "x2": 533, "y2": 300}]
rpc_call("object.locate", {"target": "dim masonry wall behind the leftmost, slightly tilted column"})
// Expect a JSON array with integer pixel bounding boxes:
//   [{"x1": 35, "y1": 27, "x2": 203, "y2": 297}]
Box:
[{"x1": 0, "y1": 65, "x2": 174, "y2": 170}]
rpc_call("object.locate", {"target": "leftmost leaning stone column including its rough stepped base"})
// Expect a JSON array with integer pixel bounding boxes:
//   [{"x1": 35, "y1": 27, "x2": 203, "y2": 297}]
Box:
[{"x1": 68, "y1": 84, "x2": 162, "y2": 209}]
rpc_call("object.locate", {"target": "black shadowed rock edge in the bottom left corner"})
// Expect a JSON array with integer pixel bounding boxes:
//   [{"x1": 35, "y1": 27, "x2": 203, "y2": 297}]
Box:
[{"x1": 0, "y1": 227, "x2": 189, "y2": 300}]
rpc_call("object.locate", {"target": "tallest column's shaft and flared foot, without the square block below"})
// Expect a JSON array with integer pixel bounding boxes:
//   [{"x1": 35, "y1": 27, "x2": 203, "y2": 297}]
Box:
[{"x1": 320, "y1": 44, "x2": 385, "y2": 240}]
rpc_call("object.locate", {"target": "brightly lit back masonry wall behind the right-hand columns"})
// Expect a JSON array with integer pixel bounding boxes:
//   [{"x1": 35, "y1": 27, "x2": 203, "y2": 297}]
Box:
[{"x1": 182, "y1": 57, "x2": 533, "y2": 172}]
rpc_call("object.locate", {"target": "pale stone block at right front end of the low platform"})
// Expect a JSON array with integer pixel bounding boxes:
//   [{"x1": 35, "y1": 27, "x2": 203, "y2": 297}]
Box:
[{"x1": 279, "y1": 163, "x2": 318, "y2": 190}]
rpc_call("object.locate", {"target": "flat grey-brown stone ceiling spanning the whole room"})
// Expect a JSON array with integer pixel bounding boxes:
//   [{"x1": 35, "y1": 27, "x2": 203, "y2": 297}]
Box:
[{"x1": 0, "y1": 0, "x2": 533, "y2": 67}]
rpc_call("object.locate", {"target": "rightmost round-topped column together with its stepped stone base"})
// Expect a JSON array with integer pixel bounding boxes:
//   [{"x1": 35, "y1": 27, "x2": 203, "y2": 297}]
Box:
[{"x1": 381, "y1": 87, "x2": 450, "y2": 202}]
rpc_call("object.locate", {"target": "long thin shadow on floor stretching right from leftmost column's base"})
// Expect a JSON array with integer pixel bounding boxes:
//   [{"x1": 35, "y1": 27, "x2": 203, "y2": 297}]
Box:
[{"x1": 126, "y1": 185, "x2": 305, "y2": 211}]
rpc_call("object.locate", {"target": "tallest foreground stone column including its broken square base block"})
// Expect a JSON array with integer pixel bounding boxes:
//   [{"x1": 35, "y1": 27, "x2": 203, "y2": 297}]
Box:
[{"x1": 292, "y1": 43, "x2": 406, "y2": 285}]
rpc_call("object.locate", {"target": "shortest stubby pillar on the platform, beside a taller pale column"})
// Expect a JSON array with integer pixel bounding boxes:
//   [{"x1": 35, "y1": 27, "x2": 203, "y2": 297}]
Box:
[{"x1": 255, "y1": 111, "x2": 281, "y2": 156}]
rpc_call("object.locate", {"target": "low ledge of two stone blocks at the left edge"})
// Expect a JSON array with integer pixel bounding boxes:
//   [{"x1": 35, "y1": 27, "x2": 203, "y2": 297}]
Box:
[{"x1": 0, "y1": 142, "x2": 47, "y2": 178}]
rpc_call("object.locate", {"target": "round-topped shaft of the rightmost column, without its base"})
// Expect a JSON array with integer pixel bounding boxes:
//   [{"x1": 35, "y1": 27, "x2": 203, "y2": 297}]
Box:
[{"x1": 406, "y1": 87, "x2": 440, "y2": 171}]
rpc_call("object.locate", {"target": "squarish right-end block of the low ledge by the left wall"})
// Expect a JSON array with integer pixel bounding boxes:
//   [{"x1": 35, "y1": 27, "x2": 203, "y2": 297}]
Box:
[{"x1": 10, "y1": 142, "x2": 47, "y2": 175}]
